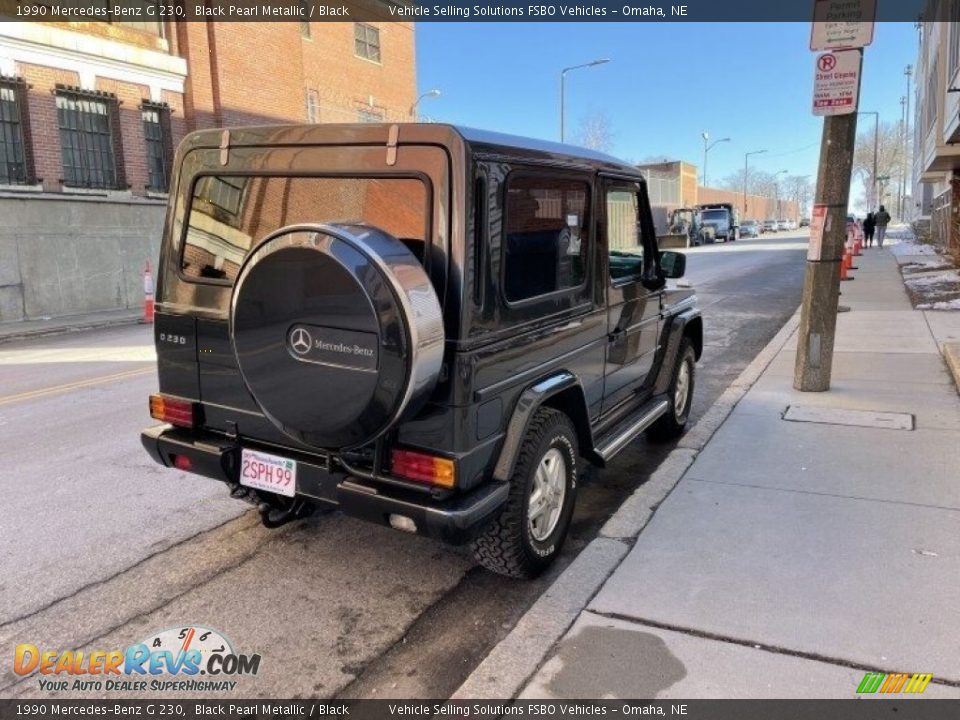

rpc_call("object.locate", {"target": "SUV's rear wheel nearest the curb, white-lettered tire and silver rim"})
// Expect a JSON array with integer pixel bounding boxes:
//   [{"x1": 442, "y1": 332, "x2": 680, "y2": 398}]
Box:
[{"x1": 472, "y1": 408, "x2": 579, "y2": 580}]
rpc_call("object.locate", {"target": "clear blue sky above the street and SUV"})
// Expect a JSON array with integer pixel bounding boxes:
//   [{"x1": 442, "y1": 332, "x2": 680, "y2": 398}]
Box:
[{"x1": 417, "y1": 22, "x2": 917, "y2": 190}]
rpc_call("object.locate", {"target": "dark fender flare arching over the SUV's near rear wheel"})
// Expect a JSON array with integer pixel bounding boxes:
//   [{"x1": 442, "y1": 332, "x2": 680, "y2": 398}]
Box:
[{"x1": 493, "y1": 370, "x2": 596, "y2": 482}]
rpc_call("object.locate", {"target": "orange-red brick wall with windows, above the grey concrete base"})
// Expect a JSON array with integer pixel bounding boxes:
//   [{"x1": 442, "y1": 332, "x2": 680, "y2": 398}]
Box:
[{"x1": 0, "y1": 22, "x2": 416, "y2": 196}]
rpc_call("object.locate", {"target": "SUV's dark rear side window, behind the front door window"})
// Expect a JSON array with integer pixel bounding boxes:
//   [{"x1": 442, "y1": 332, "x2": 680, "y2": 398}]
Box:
[{"x1": 503, "y1": 175, "x2": 590, "y2": 302}]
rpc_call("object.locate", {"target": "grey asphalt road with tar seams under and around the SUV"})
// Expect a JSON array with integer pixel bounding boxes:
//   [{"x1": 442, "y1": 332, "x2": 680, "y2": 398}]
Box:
[{"x1": 0, "y1": 233, "x2": 806, "y2": 697}]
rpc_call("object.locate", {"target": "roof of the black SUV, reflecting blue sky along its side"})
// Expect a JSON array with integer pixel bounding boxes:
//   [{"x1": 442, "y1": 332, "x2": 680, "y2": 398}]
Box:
[{"x1": 184, "y1": 123, "x2": 644, "y2": 181}]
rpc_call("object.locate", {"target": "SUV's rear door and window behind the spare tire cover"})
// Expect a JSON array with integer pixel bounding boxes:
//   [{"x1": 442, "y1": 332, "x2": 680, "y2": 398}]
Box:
[{"x1": 159, "y1": 141, "x2": 450, "y2": 445}]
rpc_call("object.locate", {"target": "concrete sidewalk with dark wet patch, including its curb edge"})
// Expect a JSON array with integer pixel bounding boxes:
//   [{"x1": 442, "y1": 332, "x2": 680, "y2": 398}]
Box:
[{"x1": 454, "y1": 242, "x2": 960, "y2": 699}]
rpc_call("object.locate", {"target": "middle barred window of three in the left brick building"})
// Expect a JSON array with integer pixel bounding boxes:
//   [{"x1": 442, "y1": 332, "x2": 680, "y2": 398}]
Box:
[{"x1": 56, "y1": 88, "x2": 121, "y2": 189}]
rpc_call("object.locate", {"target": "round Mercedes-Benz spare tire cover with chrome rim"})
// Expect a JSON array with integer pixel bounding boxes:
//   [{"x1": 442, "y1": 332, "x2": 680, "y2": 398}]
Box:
[{"x1": 230, "y1": 224, "x2": 444, "y2": 450}]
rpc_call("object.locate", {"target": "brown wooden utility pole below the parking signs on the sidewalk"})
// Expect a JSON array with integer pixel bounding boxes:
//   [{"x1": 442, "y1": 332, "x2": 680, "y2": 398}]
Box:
[{"x1": 793, "y1": 49, "x2": 863, "y2": 392}]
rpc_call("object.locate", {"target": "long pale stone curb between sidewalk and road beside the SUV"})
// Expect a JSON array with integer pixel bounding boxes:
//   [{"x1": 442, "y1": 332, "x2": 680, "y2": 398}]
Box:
[{"x1": 450, "y1": 309, "x2": 800, "y2": 700}]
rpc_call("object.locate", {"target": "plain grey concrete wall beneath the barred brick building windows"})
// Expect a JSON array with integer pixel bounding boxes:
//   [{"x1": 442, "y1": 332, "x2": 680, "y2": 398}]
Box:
[{"x1": 0, "y1": 194, "x2": 166, "y2": 322}]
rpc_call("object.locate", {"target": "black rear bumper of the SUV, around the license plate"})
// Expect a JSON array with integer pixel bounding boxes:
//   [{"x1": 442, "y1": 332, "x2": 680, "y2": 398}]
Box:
[{"x1": 140, "y1": 425, "x2": 509, "y2": 545}]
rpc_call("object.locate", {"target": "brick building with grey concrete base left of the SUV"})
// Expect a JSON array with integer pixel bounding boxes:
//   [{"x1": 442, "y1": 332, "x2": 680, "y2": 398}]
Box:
[{"x1": 0, "y1": 13, "x2": 416, "y2": 322}]
